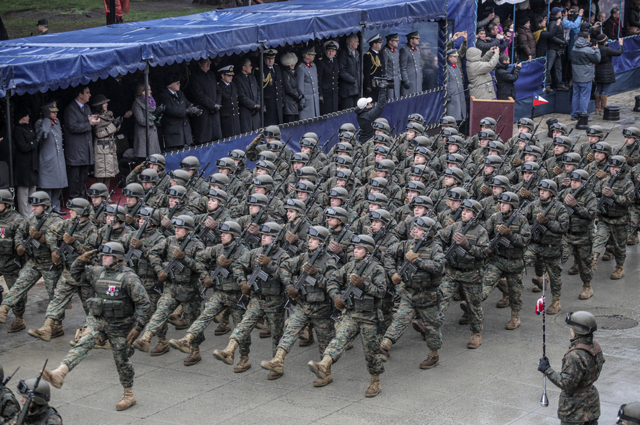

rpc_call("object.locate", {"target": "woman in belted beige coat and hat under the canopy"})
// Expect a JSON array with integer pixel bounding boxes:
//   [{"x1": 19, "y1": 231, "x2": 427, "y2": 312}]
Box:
[{"x1": 91, "y1": 94, "x2": 122, "y2": 188}]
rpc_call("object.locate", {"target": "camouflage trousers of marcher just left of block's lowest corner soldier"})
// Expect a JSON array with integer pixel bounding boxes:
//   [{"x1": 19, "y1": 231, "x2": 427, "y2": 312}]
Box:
[{"x1": 278, "y1": 300, "x2": 336, "y2": 355}]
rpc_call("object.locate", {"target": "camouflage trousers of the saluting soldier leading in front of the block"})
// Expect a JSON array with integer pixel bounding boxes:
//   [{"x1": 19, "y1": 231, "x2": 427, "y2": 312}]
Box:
[{"x1": 62, "y1": 316, "x2": 135, "y2": 388}]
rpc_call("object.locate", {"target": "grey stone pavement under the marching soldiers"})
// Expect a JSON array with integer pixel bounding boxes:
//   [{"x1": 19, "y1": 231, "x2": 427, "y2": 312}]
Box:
[{"x1": 0, "y1": 88, "x2": 640, "y2": 425}]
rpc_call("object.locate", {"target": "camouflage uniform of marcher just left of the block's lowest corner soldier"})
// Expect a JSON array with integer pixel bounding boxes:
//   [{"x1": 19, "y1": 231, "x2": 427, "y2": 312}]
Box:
[{"x1": 278, "y1": 251, "x2": 337, "y2": 355}]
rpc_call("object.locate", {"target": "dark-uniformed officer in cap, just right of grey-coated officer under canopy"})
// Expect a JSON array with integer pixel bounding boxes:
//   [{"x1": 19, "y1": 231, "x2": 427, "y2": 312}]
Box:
[{"x1": 316, "y1": 40, "x2": 340, "y2": 115}]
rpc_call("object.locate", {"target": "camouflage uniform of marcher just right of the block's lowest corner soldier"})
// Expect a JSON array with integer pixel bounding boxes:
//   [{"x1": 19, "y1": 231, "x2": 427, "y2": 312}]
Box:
[{"x1": 384, "y1": 235, "x2": 444, "y2": 350}]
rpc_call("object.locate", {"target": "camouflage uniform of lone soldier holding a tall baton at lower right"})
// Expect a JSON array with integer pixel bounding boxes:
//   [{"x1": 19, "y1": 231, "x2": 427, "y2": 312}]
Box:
[{"x1": 544, "y1": 335, "x2": 604, "y2": 425}]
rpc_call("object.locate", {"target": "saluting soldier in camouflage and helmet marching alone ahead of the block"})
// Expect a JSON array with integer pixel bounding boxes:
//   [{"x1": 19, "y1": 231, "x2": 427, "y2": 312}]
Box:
[{"x1": 42, "y1": 242, "x2": 150, "y2": 410}]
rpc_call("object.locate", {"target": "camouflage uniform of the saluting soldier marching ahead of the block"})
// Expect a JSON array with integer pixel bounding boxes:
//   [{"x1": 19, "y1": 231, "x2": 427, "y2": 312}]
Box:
[{"x1": 62, "y1": 261, "x2": 150, "y2": 388}]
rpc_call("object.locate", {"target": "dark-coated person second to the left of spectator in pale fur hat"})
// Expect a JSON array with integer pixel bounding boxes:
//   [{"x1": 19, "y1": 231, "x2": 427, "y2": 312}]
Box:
[{"x1": 234, "y1": 58, "x2": 262, "y2": 133}]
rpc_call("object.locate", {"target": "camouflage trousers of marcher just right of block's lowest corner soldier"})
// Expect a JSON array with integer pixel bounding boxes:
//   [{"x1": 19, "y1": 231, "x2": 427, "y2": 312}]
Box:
[{"x1": 384, "y1": 289, "x2": 444, "y2": 350}]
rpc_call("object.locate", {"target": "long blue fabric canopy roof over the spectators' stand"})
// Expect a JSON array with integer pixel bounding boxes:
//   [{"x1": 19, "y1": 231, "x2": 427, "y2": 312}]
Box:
[{"x1": 0, "y1": 0, "x2": 447, "y2": 97}]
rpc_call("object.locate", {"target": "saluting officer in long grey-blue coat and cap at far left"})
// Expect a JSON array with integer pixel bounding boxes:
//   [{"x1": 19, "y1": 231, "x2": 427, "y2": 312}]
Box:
[{"x1": 35, "y1": 102, "x2": 67, "y2": 214}]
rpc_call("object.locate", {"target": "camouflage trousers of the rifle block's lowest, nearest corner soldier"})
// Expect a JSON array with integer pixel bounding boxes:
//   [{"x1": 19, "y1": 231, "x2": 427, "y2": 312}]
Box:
[{"x1": 324, "y1": 310, "x2": 384, "y2": 375}]
